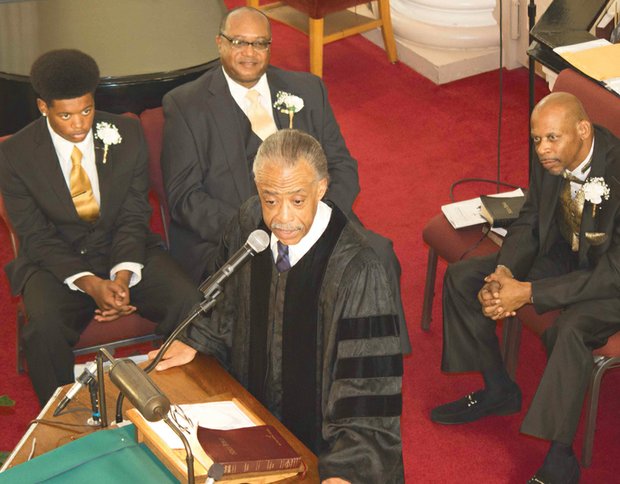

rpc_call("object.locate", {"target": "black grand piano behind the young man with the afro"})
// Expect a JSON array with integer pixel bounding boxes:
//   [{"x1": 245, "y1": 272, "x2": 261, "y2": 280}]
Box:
[{"x1": 0, "y1": 0, "x2": 226, "y2": 135}]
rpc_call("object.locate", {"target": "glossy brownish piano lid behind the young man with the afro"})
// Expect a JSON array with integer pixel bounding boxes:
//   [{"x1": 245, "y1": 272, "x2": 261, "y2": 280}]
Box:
[{"x1": 0, "y1": 0, "x2": 226, "y2": 79}]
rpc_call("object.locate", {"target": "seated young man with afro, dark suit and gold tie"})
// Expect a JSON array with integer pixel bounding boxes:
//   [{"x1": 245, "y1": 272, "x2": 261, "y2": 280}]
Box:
[{"x1": 0, "y1": 49, "x2": 201, "y2": 404}]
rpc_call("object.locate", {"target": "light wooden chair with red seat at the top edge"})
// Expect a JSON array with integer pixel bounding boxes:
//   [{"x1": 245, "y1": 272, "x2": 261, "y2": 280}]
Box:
[{"x1": 247, "y1": 0, "x2": 398, "y2": 77}]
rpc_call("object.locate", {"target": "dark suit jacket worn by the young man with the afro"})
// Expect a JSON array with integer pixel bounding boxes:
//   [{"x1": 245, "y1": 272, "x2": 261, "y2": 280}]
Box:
[{"x1": 0, "y1": 112, "x2": 160, "y2": 293}]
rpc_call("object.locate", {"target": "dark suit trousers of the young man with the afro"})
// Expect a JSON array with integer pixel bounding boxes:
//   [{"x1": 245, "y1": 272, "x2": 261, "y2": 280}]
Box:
[{"x1": 23, "y1": 248, "x2": 202, "y2": 405}]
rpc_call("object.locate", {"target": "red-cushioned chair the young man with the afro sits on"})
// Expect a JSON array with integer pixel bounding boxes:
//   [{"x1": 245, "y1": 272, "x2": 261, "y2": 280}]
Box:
[{"x1": 0, "y1": 130, "x2": 161, "y2": 373}]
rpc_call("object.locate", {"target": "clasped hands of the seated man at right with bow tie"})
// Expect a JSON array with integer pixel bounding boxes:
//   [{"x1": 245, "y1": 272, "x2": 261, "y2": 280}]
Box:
[{"x1": 478, "y1": 265, "x2": 532, "y2": 321}]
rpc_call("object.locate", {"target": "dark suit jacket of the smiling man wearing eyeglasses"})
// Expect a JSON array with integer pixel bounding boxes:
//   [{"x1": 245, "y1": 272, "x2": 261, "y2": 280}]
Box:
[{"x1": 161, "y1": 65, "x2": 359, "y2": 281}]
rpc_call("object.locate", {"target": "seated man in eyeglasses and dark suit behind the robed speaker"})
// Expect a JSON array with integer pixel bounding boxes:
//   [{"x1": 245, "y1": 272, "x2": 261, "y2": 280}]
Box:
[{"x1": 161, "y1": 7, "x2": 411, "y2": 354}]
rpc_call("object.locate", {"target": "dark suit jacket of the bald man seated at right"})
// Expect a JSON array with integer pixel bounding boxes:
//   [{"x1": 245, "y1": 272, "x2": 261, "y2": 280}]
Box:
[{"x1": 497, "y1": 126, "x2": 620, "y2": 312}]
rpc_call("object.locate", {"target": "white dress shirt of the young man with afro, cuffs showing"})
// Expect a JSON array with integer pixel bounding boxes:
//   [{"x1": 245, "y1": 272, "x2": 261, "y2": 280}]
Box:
[{"x1": 47, "y1": 119, "x2": 144, "y2": 291}]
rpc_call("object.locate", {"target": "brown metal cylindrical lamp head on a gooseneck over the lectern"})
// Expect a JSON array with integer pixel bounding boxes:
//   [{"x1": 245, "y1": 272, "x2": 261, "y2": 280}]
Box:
[{"x1": 110, "y1": 359, "x2": 170, "y2": 422}]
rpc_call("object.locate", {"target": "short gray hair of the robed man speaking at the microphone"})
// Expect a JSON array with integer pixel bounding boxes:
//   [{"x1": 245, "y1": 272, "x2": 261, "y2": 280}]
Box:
[{"x1": 252, "y1": 129, "x2": 329, "y2": 180}]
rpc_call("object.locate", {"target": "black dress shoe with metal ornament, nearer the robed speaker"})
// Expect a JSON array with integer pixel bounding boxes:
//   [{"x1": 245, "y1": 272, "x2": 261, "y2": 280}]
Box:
[{"x1": 431, "y1": 384, "x2": 521, "y2": 424}]
